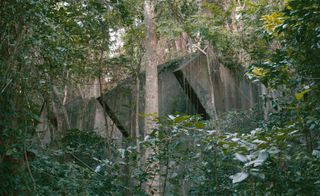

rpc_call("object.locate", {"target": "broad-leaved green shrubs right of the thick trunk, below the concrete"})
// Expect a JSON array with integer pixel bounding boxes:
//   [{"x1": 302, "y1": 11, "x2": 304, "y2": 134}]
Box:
[{"x1": 141, "y1": 116, "x2": 320, "y2": 195}]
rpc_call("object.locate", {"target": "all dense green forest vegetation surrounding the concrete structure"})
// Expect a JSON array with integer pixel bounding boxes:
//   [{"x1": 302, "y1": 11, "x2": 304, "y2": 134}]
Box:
[{"x1": 0, "y1": 0, "x2": 320, "y2": 195}]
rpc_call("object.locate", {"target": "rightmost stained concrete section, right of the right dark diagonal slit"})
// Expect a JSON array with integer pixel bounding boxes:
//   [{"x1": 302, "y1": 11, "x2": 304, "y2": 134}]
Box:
[{"x1": 176, "y1": 54, "x2": 260, "y2": 118}]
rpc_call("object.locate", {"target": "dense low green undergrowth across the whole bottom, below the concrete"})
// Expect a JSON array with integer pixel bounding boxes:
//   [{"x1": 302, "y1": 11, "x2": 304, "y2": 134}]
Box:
[{"x1": 1, "y1": 112, "x2": 320, "y2": 195}]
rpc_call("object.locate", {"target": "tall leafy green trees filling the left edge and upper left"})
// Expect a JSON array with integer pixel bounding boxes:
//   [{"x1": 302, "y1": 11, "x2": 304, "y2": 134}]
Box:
[{"x1": 0, "y1": 0, "x2": 134, "y2": 195}]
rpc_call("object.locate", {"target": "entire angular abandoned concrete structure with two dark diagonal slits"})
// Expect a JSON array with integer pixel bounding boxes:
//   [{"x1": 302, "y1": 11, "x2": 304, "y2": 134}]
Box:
[{"x1": 38, "y1": 50, "x2": 263, "y2": 144}]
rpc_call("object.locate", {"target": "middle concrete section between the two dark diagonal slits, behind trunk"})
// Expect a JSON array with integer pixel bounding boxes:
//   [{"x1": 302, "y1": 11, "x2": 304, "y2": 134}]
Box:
[{"x1": 102, "y1": 56, "x2": 197, "y2": 136}]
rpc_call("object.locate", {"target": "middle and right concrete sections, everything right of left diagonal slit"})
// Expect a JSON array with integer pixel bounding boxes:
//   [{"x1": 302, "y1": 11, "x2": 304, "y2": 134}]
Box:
[{"x1": 102, "y1": 53, "x2": 261, "y2": 136}]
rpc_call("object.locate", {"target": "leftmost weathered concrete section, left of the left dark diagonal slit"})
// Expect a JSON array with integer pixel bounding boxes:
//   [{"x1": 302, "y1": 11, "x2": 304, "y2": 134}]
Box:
[{"x1": 37, "y1": 97, "x2": 122, "y2": 146}]
